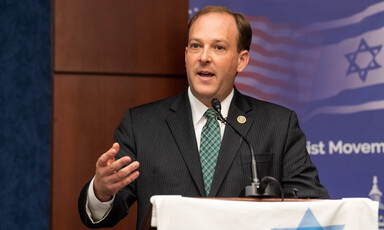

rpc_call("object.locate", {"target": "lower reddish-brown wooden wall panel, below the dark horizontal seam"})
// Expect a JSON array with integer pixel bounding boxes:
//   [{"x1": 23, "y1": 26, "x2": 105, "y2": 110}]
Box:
[{"x1": 51, "y1": 74, "x2": 186, "y2": 230}]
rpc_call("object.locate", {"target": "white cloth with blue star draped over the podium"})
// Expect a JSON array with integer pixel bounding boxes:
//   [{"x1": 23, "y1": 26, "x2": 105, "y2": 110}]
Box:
[{"x1": 151, "y1": 196, "x2": 379, "y2": 230}]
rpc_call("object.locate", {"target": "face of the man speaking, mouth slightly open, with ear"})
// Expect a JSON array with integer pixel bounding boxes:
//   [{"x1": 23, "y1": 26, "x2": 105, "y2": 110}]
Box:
[{"x1": 185, "y1": 12, "x2": 249, "y2": 107}]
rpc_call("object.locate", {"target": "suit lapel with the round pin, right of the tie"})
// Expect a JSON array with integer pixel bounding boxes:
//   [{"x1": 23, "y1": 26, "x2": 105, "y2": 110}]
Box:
[{"x1": 209, "y1": 89, "x2": 253, "y2": 196}]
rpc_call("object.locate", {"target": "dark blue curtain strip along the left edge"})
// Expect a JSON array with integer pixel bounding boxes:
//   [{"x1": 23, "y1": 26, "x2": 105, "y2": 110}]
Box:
[{"x1": 0, "y1": 0, "x2": 51, "y2": 230}]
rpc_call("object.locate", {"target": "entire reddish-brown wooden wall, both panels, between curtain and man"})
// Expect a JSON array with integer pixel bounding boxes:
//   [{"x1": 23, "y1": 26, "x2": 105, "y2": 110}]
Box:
[{"x1": 51, "y1": 0, "x2": 188, "y2": 230}]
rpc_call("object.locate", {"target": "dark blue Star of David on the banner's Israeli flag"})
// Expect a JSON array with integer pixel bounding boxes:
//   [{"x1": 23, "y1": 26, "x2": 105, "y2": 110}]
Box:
[{"x1": 344, "y1": 39, "x2": 382, "y2": 81}]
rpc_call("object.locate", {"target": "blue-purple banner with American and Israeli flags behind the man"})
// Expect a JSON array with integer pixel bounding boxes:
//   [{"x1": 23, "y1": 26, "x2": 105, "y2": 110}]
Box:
[{"x1": 189, "y1": 0, "x2": 384, "y2": 229}]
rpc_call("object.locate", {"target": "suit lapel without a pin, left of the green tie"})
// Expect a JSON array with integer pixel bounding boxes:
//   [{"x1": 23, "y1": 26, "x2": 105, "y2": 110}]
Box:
[{"x1": 166, "y1": 91, "x2": 205, "y2": 196}]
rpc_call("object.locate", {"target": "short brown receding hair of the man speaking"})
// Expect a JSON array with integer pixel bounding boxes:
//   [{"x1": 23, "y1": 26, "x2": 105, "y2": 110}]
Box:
[{"x1": 188, "y1": 6, "x2": 252, "y2": 52}]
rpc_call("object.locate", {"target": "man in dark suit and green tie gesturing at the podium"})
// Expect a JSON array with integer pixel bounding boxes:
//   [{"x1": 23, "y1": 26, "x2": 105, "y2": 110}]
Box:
[{"x1": 79, "y1": 6, "x2": 328, "y2": 228}]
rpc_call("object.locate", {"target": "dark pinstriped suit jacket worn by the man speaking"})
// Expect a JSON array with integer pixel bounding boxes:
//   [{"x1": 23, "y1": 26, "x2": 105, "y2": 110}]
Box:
[{"x1": 79, "y1": 89, "x2": 328, "y2": 228}]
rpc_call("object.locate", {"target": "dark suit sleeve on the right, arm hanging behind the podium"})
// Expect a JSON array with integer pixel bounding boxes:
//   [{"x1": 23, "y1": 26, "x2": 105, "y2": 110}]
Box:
[{"x1": 282, "y1": 112, "x2": 329, "y2": 198}]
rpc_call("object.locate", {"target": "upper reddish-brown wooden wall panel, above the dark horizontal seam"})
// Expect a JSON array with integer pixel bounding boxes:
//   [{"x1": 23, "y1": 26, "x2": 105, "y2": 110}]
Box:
[{"x1": 53, "y1": 0, "x2": 188, "y2": 75}]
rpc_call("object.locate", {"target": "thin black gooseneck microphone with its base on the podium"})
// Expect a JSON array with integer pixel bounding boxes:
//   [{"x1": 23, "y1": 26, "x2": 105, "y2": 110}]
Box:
[{"x1": 211, "y1": 98, "x2": 284, "y2": 200}]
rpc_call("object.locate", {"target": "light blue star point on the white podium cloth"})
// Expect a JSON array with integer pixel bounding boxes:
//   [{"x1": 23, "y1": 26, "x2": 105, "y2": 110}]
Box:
[{"x1": 272, "y1": 208, "x2": 344, "y2": 230}]
